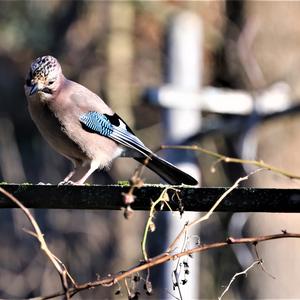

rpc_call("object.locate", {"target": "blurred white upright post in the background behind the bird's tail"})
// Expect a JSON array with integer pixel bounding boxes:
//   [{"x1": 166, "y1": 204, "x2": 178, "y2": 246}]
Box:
[{"x1": 163, "y1": 12, "x2": 203, "y2": 299}]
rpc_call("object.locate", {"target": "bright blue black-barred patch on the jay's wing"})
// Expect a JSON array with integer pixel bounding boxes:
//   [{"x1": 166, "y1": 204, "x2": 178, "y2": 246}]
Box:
[{"x1": 79, "y1": 111, "x2": 113, "y2": 137}]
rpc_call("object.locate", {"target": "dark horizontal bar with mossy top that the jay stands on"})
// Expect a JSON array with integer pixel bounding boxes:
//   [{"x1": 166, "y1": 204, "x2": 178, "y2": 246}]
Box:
[{"x1": 0, "y1": 184, "x2": 300, "y2": 213}]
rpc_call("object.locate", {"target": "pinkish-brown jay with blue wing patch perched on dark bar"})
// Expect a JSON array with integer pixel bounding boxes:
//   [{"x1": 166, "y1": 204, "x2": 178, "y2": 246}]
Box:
[{"x1": 24, "y1": 55, "x2": 198, "y2": 185}]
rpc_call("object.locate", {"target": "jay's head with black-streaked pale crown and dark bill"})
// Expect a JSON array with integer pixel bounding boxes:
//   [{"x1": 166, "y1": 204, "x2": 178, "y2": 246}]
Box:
[{"x1": 25, "y1": 55, "x2": 62, "y2": 96}]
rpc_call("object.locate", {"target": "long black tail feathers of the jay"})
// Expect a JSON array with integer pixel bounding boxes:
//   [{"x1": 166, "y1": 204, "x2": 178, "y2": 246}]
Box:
[{"x1": 134, "y1": 154, "x2": 198, "y2": 185}]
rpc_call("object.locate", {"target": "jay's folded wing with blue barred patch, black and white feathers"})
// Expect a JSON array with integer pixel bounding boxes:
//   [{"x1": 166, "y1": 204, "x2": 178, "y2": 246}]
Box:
[{"x1": 79, "y1": 111, "x2": 152, "y2": 157}]
